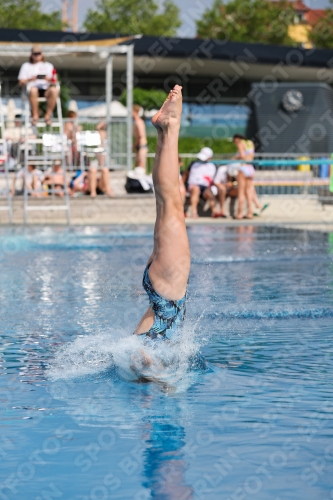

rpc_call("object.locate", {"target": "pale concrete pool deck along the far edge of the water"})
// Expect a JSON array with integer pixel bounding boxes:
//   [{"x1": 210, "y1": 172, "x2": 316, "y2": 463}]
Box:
[{"x1": 0, "y1": 172, "x2": 333, "y2": 231}]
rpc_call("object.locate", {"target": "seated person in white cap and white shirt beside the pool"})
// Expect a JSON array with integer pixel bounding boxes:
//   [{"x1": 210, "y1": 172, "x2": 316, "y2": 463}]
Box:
[{"x1": 183, "y1": 148, "x2": 217, "y2": 219}]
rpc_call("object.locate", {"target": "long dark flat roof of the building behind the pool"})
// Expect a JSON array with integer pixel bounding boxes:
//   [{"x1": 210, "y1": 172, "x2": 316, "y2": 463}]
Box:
[{"x1": 0, "y1": 29, "x2": 332, "y2": 81}]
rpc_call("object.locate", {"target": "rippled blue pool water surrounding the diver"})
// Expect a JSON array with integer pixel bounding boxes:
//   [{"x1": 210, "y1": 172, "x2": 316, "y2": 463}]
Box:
[{"x1": 0, "y1": 226, "x2": 333, "y2": 500}]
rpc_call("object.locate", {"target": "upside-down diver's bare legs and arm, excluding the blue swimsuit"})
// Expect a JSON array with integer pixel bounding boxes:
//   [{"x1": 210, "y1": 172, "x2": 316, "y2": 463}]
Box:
[{"x1": 135, "y1": 85, "x2": 190, "y2": 334}]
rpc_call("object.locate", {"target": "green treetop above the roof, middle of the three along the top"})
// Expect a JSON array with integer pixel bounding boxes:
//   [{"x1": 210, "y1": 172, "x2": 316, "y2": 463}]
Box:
[{"x1": 84, "y1": 0, "x2": 182, "y2": 36}]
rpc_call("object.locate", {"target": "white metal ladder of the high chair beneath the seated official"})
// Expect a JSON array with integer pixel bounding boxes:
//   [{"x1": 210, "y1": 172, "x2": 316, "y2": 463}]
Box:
[{"x1": 23, "y1": 90, "x2": 70, "y2": 224}]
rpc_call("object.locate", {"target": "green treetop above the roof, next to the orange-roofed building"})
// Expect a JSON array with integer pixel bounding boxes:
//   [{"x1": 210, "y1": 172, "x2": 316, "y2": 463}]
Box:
[{"x1": 197, "y1": 0, "x2": 295, "y2": 45}]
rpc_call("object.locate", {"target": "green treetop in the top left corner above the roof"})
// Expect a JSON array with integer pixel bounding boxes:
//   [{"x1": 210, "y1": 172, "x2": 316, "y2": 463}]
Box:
[{"x1": 0, "y1": 0, "x2": 63, "y2": 30}]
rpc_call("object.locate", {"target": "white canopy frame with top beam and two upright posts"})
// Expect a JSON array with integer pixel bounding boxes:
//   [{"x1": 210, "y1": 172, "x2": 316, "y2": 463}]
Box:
[{"x1": 0, "y1": 42, "x2": 136, "y2": 170}]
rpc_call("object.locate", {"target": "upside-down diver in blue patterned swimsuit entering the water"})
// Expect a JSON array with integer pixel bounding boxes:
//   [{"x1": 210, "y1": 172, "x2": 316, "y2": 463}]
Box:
[{"x1": 134, "y1": 85, "x2": 190, "y2": 340}]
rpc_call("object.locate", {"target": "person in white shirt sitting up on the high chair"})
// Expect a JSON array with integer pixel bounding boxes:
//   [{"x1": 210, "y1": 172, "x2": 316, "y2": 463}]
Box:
[{"x1": 18, "y1": 45, "x2": 58, "y2": 125}]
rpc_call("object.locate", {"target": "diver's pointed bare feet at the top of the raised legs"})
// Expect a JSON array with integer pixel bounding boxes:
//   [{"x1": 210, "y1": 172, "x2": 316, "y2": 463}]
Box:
[{"x1": 151, "y1": 85, "x2": 182, "y2": 132}]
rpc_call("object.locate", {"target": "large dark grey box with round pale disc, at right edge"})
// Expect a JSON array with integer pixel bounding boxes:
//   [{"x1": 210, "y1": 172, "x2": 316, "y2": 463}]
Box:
[{"x1": 247, "y1": 82, "x2": 333, "y2": 153}]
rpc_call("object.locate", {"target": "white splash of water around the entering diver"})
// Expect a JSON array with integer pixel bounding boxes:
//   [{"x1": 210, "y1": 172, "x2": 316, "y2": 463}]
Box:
[{"x1": 47, "y1": 328, "x2": 206, "y2": 392}]
